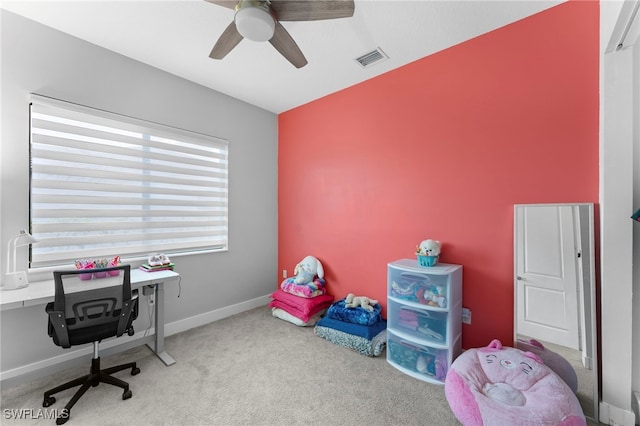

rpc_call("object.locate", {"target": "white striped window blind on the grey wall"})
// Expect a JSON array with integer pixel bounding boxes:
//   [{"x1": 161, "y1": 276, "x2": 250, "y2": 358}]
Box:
[{"x1": 30, "y1": 95, "x2": 228, "y2": 268}]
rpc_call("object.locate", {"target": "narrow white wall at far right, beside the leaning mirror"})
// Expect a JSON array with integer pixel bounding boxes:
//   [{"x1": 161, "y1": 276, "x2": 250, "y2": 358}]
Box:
[{"x1": 600, "y1": 1, "x2": 640, "y2": 425}]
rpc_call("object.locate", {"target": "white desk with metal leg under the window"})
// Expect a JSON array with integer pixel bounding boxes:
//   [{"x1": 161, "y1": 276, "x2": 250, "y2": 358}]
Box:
[{"x1": 0, "y1": 268, "x2": 180, "y2": 365}]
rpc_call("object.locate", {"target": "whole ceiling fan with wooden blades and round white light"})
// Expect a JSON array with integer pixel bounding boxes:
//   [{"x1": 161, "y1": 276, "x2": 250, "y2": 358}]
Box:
[{"x1": 206, "y1": 0, "x2": 355, "y2": 68}]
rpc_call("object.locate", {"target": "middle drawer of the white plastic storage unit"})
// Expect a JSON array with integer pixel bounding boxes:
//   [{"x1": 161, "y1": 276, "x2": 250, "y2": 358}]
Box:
[{"x1": 387, "y1": 300, "x2": 448, "y2": 345}]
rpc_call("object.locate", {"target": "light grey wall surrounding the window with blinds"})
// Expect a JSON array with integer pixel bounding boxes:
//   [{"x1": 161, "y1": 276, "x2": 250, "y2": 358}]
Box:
[{"x1": 0, "y1": 10, "x2": 278, "y2": 379}]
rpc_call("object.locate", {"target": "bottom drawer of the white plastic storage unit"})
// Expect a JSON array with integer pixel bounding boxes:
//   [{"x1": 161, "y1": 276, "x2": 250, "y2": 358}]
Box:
[{"x1": 387, "y1": 330, "x2": 448, "y2": 382}]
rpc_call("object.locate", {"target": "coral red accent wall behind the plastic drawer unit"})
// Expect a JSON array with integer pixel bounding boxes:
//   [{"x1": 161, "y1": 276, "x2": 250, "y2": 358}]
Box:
[{"x1": 277, "y1": 1, "x2": 599, "y2": 348}]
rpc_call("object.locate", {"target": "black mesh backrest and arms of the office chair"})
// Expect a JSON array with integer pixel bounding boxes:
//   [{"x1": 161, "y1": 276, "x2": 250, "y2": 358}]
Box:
[{"x1": 47, "y1": 265, "x2": 137, "y2": 348}]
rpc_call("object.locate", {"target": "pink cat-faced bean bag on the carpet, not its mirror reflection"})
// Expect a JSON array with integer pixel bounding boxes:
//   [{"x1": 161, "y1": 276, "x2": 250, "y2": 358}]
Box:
[{"x1": 444, "y1": 340, "x2": 587, "y2": 426}]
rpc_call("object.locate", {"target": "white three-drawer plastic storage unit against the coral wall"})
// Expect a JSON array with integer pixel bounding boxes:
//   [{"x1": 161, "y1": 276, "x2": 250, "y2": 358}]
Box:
[{"x1": 387, "y1": 259, "x2": 462, "y2": 384}]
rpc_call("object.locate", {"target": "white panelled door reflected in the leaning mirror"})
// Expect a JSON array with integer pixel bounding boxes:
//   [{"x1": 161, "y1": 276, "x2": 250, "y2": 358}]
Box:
[{"x1": 515, "y1": 204, "x2": 580, "y2": 350}]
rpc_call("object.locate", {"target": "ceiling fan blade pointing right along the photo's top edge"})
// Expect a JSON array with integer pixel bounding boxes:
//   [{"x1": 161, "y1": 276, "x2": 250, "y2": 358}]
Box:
[{"x1": 271, "y1": 0, "x2": 355, "y2": 21}]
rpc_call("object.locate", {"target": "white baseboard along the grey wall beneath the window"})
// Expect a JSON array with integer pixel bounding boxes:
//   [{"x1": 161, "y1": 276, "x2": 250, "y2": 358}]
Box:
[{"x1": 0, "y1": 296, "x2": 270, "y2": 387}]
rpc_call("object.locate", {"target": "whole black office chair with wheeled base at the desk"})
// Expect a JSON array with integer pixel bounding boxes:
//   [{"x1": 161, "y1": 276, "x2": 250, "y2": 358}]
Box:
[{"x1": 42, "y1": 265, "x2": 140, "y2": 425}]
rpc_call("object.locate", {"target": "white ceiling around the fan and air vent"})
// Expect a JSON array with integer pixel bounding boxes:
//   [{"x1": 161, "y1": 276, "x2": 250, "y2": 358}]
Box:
[{"x1": 0, "y1": 0, "x2": 564, "y2": 113}]
